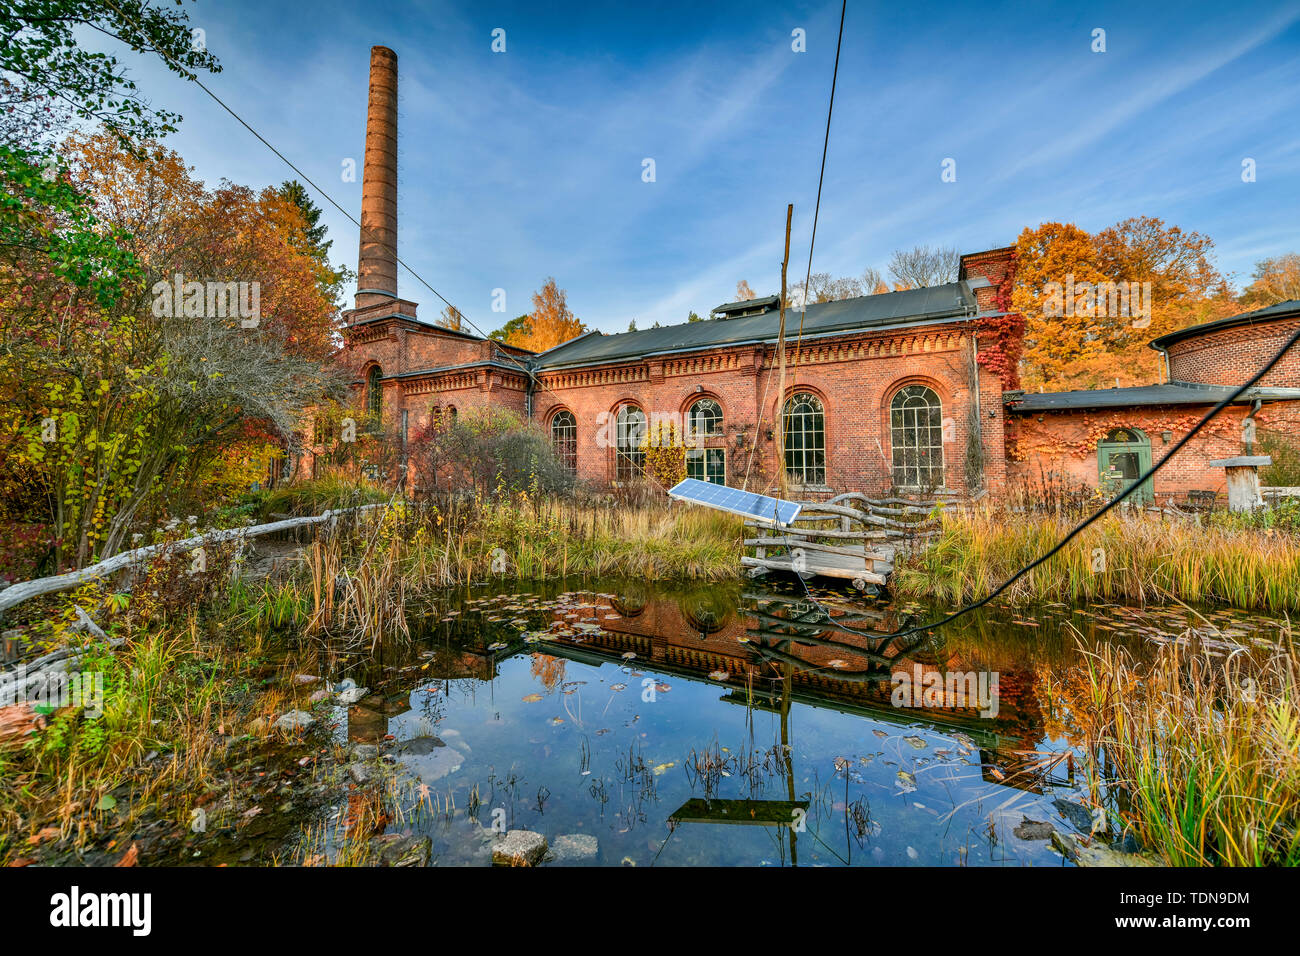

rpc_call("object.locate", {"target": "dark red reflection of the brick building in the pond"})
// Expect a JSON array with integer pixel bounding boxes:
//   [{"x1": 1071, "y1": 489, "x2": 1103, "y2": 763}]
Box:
[{"x1": 530, "y1": 585, "x2": 1043, "y2": 750}]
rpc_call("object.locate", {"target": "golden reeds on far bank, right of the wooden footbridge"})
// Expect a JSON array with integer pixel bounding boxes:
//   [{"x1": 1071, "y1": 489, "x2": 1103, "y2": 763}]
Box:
[{"x1": 896, "y1": 510, "x2": 1300, "y2": 613}]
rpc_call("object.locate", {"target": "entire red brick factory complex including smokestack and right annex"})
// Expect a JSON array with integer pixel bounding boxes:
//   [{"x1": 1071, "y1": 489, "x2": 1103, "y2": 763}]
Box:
[{"x1": 317, "y1": 47, "x2": 1300, "y2": 509}]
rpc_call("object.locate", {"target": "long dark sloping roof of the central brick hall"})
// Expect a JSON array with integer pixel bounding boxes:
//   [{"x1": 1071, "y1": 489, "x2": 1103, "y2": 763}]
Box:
[{"x1": 529, "y1": 282, "x2": 976, "y2": 371}]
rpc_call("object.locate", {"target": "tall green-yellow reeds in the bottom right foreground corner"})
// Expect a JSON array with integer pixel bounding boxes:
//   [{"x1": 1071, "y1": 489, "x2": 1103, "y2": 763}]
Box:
[{"x1": 1045, "y1": 632, "x2": 1300, "y2": 866}]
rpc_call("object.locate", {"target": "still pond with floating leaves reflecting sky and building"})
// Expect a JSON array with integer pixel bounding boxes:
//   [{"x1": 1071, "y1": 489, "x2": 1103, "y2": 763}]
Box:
[{"x1": 299, "y1": 581, "x2": 1277, "y2": 866}]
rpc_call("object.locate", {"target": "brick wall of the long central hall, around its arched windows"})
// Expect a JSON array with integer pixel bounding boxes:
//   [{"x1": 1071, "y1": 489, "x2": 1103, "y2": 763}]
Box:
[{"x1": 534, "y1": 323, "x2": 1001, "y2": 497}]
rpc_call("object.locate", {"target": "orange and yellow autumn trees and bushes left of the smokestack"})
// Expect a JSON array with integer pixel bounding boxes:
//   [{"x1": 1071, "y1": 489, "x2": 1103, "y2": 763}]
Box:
[{"x1": 0, "y1": 133, "x2": 342, "y2": 566}]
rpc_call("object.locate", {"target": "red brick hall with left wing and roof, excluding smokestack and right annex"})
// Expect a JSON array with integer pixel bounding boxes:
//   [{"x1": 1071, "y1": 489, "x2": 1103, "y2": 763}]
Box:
[{"x1": 343, "y1": 250, "x2": 1011, "y2": 497}]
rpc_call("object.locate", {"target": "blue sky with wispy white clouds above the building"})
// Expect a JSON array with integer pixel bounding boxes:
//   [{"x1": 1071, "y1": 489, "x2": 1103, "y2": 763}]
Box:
[{"x1": 96, "y1": 0, "x2": 1300, "y2": 332}]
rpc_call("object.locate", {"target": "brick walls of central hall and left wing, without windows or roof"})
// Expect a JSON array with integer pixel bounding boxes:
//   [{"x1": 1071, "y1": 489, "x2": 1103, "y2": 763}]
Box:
[{"x1": 325, "y1": 248, "x2": 1014, "y2": 498}]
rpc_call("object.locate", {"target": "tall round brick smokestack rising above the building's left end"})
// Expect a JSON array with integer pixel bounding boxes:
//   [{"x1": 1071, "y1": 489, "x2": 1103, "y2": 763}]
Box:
[{"x1": 356, "y1": 47, "x2": 398, "y2": 308}]
